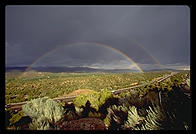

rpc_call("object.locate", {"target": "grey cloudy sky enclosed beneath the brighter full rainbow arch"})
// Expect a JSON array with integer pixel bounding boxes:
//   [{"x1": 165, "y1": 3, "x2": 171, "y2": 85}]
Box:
[{"x1": 34, "y1": 43, "x2": 133, "y2": 68}]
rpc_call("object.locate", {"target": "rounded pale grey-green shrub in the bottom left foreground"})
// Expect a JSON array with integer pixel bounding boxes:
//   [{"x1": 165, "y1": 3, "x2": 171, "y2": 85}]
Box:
[{"x1": 22, "y1": 97, "x2": 64, "y2": 130}]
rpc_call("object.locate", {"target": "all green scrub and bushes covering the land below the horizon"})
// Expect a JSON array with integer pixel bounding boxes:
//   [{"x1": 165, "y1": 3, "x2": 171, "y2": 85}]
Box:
[{"x1": 5, "y1": 71, "x2": 192, "y2": 130}]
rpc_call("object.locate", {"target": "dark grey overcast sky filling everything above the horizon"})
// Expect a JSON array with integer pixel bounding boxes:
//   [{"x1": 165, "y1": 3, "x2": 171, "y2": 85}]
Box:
[{"x1": 5, "y1": 5, "x2": 190, "y2": 69}]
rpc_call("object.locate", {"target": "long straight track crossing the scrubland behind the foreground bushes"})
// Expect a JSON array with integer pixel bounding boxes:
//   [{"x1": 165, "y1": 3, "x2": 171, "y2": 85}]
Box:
[{"x1": 5, "y1": 72, "x2": 177, "y2": 111}]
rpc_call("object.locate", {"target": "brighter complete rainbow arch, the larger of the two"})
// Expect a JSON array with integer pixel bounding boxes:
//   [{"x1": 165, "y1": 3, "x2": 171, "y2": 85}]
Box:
[{"x1": 24, "y1": 42, "x2": 144, "y2": 73}]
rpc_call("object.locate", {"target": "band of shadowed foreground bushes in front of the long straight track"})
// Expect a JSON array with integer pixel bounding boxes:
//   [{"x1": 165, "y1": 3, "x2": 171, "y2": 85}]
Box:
[{"x1": 7, "y1": 78, "x2": 192, "y2": 130}]
